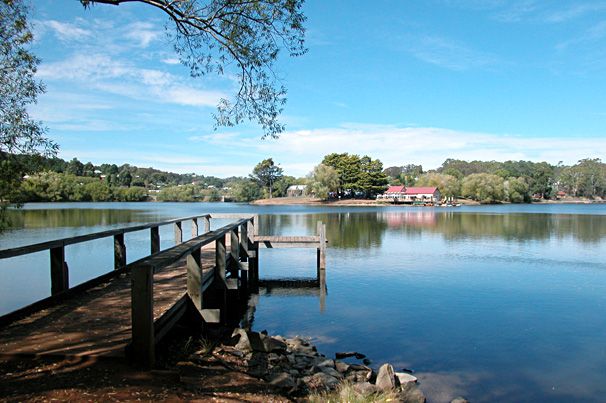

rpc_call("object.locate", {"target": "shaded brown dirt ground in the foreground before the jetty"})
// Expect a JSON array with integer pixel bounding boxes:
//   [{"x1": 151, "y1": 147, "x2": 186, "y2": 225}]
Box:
[{"x1": 0, "y1": 330, "x2": 291, "y2": 402}]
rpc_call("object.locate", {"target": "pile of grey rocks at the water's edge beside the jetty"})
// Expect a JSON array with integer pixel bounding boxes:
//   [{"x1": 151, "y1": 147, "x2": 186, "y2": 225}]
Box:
[{"x1": 176, "y1": 328, "x2": 466, "y2": 403}]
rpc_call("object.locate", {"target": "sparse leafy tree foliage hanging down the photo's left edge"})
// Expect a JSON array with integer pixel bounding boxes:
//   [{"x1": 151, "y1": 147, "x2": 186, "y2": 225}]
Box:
[{"x1": 0, "y1": 0, "x2": 57, "y2": 230}]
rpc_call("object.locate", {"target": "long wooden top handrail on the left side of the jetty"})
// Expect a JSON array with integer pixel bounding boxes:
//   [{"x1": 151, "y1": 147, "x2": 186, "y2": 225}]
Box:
[{"x1": 0, "y1": 214, "x2": 211, "y2": 259}]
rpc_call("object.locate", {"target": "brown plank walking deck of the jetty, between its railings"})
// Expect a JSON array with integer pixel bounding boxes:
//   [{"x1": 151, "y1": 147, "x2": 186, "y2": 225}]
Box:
[{"x1": 0, "y1": 249, "x2": 215, "y2": 357}]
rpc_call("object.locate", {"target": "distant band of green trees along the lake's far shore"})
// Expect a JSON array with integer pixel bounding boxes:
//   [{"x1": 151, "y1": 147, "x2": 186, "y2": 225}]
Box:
[{"x1": 0, "y1": 153, "x2": 606, "y2": 203}]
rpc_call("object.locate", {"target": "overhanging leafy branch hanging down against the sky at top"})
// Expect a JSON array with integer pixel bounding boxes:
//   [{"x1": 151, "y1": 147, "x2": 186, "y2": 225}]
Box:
[{"x1": 80, "y1": 0, "x2": 307, "y2": 137}]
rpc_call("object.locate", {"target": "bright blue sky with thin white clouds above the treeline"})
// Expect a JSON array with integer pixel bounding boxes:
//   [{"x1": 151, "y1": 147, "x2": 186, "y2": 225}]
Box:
[{"x1": 30, "y1": 0, "x2": 606, "y2": 177}]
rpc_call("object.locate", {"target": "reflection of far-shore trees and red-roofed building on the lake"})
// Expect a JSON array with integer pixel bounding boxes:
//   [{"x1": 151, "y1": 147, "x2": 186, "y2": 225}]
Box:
[{"x1": 261, "y1": 209, "x2": 606, "y2": 249}]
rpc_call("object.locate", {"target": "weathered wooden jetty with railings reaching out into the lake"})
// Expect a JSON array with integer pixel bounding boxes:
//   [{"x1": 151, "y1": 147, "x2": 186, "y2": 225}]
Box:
[{"x1": 0, "y1": 214, "x2": 326, "y2": 366}]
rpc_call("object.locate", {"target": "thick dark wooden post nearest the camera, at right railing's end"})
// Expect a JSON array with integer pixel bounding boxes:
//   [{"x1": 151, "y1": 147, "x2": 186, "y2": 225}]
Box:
[{"x1": 131, "y1": 265, "x2": 156, "y2": 367}]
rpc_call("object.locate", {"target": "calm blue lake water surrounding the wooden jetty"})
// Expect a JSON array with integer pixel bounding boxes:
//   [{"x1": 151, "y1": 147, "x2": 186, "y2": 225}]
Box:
[{"x1": 0, "y1": 203, "x2": 606, "y2": 402}]
